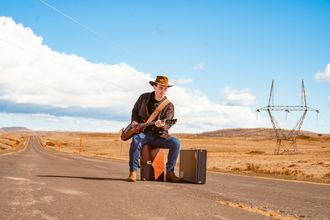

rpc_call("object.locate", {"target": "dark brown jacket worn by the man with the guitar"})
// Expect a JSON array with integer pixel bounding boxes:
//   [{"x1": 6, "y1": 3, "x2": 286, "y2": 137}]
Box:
[{"x1": 132, "y1": 92, "x2": 174, "y2": 138}]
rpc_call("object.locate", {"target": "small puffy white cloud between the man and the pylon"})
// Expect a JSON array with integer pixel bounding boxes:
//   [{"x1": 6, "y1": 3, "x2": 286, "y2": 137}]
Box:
[{"x1": 221, "y1": 87, "x2": 256, "y2": 106}]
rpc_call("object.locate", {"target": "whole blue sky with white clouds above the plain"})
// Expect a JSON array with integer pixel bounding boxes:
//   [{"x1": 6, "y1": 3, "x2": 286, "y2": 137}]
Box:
[{"x1": 0, "y1": 0, "x2": 330, "y2": 133}]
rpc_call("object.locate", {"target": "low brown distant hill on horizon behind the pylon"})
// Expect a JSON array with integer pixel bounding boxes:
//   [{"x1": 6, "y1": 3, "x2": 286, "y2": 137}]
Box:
[{"x1": 197, "y1": 128, "x2": 327, "y2": 137}]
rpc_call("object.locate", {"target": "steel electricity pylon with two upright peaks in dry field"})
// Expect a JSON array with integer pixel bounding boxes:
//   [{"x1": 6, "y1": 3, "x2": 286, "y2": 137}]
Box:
[{"x1": 257, "y1": 80, "x2": 320, "y2": 154}]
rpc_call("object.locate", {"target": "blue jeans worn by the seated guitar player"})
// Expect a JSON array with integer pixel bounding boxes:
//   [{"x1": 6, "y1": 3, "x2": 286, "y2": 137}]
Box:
[{"x1": 129, "y1": 132, "x2": 180, "y2": 173}]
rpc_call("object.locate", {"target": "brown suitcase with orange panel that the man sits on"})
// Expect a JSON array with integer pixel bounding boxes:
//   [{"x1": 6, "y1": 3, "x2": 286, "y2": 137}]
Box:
[{"x1": 140, "y1": 145, "x2": 164, "y2": 181}]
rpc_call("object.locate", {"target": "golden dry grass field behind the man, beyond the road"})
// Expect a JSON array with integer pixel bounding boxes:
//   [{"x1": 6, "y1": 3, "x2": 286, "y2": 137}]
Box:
[{"x1": 0, "y1": 132, "x2": 330, "y2": 184}]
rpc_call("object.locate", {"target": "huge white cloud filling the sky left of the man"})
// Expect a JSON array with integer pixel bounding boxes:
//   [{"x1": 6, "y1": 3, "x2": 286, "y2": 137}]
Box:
[{"x1": 0, "y1": 17, "x2": 151, "y2": 113}]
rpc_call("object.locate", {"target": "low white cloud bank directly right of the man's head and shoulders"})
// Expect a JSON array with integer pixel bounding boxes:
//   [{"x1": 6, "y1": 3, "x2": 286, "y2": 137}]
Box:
[{"x1": 169, "y1": 87, "x2": 265, "y2": 132}]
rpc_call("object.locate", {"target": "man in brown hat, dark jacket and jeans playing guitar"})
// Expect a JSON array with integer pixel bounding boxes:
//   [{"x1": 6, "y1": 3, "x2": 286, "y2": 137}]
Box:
[{"x1": 128, "y1": 76, "x2": 180, "y2": 182}]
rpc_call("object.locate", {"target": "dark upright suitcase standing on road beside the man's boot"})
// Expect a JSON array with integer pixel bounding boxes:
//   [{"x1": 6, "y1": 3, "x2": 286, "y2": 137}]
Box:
[{"x1": 179, "y1": 149, "x2": 207, "y2": 184}]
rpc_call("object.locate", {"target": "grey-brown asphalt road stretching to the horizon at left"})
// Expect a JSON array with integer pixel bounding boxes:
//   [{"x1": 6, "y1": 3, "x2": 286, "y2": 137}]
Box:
[{"x1": 0, "y1": 137, "x2": 330, "y2": 220}]
